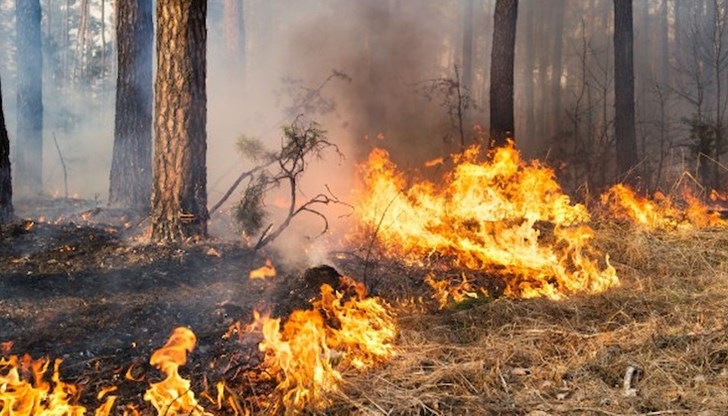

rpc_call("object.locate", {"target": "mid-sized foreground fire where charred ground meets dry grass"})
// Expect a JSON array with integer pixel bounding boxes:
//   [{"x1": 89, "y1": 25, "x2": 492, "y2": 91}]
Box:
[{"x1": 255, "y1": 278, "x2": 396, "y2": 414}]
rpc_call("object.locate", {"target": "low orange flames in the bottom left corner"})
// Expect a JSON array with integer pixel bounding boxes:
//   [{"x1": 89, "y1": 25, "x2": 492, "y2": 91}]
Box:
[{"x1": 0, "y1": 355, "x2": 86, "y2": 416}]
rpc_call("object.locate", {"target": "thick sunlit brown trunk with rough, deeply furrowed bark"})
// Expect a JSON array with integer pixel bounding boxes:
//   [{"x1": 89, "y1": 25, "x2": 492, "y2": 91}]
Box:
[{"x1": 151, "y1": 0, "x2": 208, "y2": 241}]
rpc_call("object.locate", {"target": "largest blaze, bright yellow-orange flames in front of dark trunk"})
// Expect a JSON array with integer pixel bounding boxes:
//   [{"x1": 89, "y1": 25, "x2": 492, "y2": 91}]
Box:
[{"x1": 356, "y1": 143, "x2": 618, "y2": 299}]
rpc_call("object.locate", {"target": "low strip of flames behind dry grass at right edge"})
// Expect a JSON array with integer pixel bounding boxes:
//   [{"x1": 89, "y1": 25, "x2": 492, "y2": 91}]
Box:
[{"x1": 601, "y1": 184, "x2": 724, "y2": 229}]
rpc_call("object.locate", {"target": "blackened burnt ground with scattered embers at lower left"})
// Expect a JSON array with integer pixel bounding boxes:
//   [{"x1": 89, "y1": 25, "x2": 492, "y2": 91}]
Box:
[{"x1": 0, "y1": 200, "x2": 346, "y2": 410}]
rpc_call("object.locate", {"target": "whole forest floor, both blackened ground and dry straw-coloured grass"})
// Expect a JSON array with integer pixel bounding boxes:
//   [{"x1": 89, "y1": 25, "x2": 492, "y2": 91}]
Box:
[{"x1": 0, "y1": 200, "x2": 728, "y2": 416}]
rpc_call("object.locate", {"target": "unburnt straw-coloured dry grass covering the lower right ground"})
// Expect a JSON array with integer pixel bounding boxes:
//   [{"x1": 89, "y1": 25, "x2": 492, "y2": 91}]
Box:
[{"x1": 329, "y1": 224, "x2": 728, "y2": 416}]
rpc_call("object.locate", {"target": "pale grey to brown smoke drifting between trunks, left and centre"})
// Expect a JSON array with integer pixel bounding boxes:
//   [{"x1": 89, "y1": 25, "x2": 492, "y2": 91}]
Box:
[{"x1": 0, "y1": 0, "x2": 483, "y2": 260}]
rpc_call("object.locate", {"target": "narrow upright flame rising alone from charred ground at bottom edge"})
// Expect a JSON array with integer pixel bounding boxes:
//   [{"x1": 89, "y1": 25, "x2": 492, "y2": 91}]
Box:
[{"x1": 144, "y1": 327, "x2": 211, "y2": 416}]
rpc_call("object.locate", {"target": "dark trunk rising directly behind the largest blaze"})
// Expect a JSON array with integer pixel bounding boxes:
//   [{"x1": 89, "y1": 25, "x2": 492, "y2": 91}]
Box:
[{"x1": 490, "y1": 0, "x2": 518, "y2": 146}]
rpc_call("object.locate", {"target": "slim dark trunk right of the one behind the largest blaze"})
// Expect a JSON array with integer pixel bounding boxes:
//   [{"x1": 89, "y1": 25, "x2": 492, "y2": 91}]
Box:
[{"x1": 614, "y1": 0, "x2": 638, "y2": 183}]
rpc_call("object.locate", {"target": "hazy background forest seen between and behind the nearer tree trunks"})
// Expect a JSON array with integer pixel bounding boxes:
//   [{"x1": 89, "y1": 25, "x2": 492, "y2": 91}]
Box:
[{"x1": 0, "y1": 0, "x2": 728, "y2": 206}]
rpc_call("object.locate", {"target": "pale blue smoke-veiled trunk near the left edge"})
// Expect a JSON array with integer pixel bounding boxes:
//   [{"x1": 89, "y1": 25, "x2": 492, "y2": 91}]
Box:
[{"x1": 15, "y1": 0, "x2": 43, "y2": 195}]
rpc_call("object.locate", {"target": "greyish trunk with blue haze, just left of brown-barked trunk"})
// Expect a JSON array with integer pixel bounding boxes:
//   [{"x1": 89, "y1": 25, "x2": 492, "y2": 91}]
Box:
[{"x1": 109, "y1": 0, "x2": 154, "y2": 212}]
